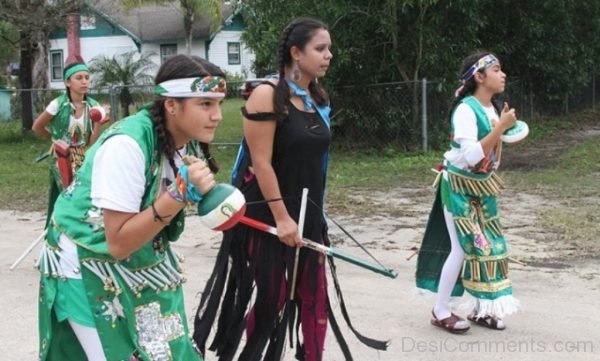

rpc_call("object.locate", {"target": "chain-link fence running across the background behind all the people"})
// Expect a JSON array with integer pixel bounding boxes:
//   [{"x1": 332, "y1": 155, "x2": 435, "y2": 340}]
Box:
[{"x1": 0, "y1": 76, "x2": 600, "y2": 151}]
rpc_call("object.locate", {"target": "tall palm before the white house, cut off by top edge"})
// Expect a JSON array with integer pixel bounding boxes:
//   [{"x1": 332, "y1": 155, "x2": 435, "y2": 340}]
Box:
[{"x1": 122, "y1": 0, "x2": 223, "y2": 55}]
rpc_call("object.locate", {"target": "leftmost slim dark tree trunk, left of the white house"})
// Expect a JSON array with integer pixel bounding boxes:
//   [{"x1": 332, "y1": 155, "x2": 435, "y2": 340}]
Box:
[{"x1": 19, "y1": 32, "x2": 33, "y2": 132}]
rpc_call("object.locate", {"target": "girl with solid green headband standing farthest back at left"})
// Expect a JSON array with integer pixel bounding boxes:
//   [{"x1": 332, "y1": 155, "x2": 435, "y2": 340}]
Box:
[{"x1": 32, "y1": 59, "x2": 108, "y2": 225}]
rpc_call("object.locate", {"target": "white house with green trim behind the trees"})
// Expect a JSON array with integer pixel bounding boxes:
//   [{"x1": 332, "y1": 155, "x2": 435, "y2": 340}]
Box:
[{"x1": 48, "y1": 0, "x2": 255, "y2": 89}]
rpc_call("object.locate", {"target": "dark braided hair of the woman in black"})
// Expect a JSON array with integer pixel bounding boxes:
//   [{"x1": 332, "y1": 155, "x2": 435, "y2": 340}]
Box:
[{"x1": 273, "y1": 17, "x2": 329, "y2": 114}]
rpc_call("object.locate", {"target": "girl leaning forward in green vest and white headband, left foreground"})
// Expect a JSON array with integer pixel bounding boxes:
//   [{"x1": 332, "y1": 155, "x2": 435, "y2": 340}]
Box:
[{"x1": 38, "y1": 55, "x2": 226, "y2": 361}]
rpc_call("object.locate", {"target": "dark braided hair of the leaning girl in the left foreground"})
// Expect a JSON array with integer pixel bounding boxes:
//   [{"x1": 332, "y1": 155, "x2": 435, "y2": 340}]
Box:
[{"x1": 150, "y1": 54, "x2": 225, "y2": 174}]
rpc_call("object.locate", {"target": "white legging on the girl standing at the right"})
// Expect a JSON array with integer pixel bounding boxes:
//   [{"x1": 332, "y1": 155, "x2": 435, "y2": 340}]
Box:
[{"x1": 434, "y1": 207, "x2": 465, "y2": 320}]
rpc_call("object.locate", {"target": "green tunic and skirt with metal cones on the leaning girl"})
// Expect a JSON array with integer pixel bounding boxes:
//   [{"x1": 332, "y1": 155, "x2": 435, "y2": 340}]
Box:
[{"x1": 39, "y1": 109, "x2": 202, "y2": 360}]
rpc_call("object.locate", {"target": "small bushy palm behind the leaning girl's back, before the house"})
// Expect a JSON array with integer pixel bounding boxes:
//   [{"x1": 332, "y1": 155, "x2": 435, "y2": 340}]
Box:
[{"x1": 90, "y1": 50, "x2": 156, "y2": 117}]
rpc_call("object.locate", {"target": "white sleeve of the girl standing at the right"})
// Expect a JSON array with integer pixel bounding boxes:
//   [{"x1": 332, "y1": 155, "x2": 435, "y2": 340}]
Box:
[{"x1": 452, "y1": 103, "x2": 485, "y2": 166}]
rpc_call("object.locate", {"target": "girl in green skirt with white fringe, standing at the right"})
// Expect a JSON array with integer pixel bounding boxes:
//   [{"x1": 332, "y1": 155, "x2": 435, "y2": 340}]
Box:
[{"x1": 416, "y1": 52, "x2": 519, "y2": 333}]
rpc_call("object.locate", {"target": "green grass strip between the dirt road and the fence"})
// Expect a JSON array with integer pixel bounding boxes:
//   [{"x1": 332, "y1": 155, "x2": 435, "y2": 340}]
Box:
[{"x1": 0, "y1": 104, "x2": 600, "y2": 249}]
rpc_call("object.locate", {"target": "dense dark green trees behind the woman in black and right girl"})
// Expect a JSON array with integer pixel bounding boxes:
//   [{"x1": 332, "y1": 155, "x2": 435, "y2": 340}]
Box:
[{"x1": 243, "y1": 0, "x2": 600, "y2": 148}]
